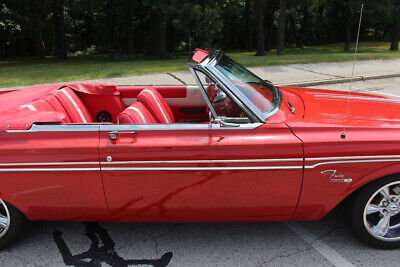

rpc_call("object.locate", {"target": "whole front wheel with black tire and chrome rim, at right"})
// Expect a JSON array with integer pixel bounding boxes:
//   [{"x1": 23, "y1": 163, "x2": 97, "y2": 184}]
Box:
[{"x1": 350, "y1": 176, "x2": 400, "y2": 248}]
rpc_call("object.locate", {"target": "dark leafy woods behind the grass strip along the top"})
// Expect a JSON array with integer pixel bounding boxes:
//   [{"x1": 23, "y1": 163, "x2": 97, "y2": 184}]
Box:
[{"x1": 0, "y1": 0, "x2": 400, "y2": 59}]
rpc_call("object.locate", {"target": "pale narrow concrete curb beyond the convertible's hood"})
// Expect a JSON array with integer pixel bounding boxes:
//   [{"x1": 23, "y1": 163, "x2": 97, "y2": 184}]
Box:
[{"x1": 276, "y1": 72, "x2": 400, "y2": 87}]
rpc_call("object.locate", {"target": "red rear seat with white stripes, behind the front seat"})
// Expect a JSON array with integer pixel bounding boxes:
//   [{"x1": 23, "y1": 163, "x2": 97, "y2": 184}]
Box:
[{"x1": 19, "y1": 88, "x2": 94, "y2": 123}]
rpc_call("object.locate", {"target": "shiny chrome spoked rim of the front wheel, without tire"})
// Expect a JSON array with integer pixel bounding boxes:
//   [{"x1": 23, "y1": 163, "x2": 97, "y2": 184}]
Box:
[{"x1": 364, "y1": 181, "x2": 400, "y2": 242}]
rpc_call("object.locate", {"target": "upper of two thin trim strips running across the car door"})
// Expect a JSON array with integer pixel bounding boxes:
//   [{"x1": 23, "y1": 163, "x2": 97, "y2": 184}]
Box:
[{"x1": 101, "y1": 158, "x2": 303, "y2": 165}]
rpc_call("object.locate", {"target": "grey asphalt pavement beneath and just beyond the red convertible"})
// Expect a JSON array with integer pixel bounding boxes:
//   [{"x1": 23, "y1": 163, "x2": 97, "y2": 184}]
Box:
[{"x1": 0, "y1": 78, "x2": 400, "y2": 266}]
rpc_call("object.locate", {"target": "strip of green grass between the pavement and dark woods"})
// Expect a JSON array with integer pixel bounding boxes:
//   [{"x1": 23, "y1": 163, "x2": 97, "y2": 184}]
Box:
[{"x1": 0, "y1": 43, "x2": 400, "y2": 87}]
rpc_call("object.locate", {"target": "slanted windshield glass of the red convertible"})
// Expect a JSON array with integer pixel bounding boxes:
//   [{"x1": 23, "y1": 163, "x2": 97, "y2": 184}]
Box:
[{"x1": 216, "y1": 56, "x2": 279, "y2": 113}]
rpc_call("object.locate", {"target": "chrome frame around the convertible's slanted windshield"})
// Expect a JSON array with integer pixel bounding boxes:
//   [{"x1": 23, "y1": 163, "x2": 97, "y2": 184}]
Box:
[{"x1": 189, "y1": 50, "x2": 282, "y2": 122}]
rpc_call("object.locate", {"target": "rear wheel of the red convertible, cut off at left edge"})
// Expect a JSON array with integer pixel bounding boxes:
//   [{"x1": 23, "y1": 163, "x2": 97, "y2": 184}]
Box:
[{"x1": 0, "y1": 199, "x2": 26, "y2": 250}]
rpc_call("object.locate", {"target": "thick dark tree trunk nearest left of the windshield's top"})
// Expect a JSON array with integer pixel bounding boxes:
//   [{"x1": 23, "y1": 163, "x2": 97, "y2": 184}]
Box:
[{"x1": 148, "y1": 10, "x2": 167, "y2": 58}]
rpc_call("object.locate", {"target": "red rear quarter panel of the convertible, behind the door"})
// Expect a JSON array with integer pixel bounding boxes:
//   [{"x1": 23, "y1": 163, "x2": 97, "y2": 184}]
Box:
[{"x1": 0, "y1": 124, "x2": 107, "y2": 220}]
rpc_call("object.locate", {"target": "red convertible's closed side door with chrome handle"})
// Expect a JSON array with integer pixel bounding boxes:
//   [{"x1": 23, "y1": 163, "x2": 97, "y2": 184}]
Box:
[{"x1": 99, "y1": 123, "x2": 303, "y2": 221}]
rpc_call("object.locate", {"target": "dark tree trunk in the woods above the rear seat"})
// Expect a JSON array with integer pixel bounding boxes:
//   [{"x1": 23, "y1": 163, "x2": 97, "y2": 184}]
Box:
[{"x1": 53, "y1": 0, "x2": 67, "y2": 59}]
